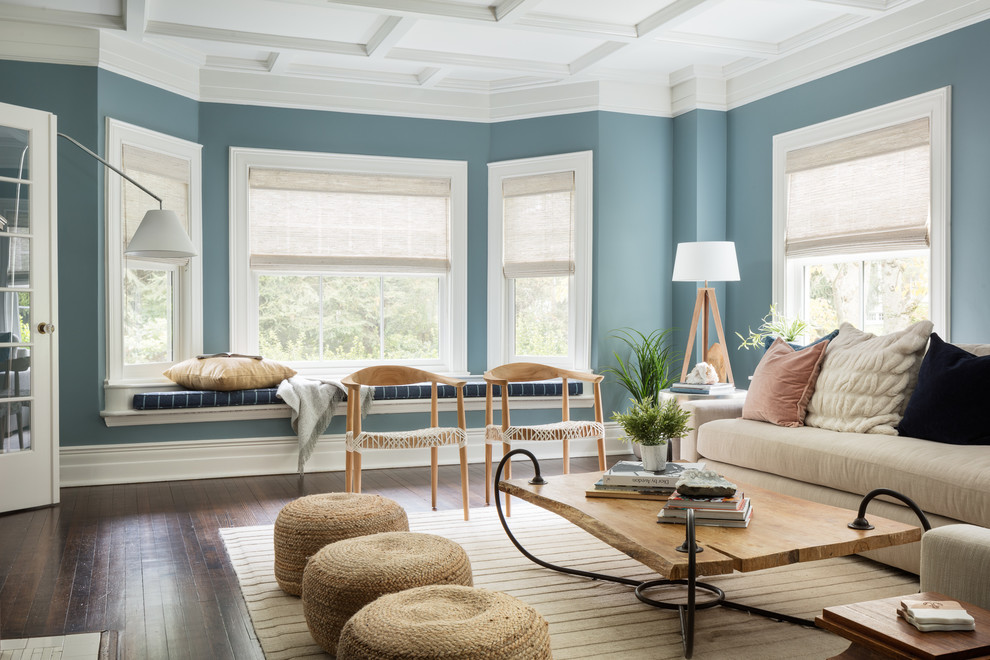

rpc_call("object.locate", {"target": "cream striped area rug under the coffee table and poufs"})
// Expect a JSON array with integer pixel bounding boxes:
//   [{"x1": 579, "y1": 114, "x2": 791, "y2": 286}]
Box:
[{"x1": 220, "y1": 499, "x2": 918, "y2": 660}]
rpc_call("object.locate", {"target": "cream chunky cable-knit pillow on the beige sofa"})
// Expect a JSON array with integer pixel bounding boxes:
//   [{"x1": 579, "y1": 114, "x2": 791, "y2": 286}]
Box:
[{"x1": 804, "y1": 321, "x2": 932, "y2": 435}]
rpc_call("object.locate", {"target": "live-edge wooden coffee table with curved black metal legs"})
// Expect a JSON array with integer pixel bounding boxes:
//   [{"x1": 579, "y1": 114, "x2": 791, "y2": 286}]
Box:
[{"x1": 495, "y1": 458, "x2": 921, "y2": 658}]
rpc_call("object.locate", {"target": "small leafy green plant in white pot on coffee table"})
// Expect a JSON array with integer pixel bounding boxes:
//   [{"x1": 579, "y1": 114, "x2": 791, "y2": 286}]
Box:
[{"x1": 612, "y1": 399, "x2": 692, "y2": 472}]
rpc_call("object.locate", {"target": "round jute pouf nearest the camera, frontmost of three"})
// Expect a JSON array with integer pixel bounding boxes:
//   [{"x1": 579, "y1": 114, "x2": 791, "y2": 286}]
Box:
[{"x1": 337, "y1": 585, "x2": 552, "y2": 660}]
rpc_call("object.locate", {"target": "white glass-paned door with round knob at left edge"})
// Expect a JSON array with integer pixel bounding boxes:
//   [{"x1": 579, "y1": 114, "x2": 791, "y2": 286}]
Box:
[{"x1": 0, "y1": 103, "x2": 59, "y2": 511}]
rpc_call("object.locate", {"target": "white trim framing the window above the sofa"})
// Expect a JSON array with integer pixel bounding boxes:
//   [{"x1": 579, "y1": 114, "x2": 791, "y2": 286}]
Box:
[{"x1": 772, "y1": 87, "x2": 952, "y2": 339}]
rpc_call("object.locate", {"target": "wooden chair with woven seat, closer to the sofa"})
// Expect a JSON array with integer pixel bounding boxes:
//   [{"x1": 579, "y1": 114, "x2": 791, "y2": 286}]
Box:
[{"x1": 484, "y1": 362, "x2": 605, "y2": 513}]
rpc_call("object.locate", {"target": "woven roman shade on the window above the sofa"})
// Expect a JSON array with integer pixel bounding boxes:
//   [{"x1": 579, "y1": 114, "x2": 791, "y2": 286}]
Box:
[{"x1": 786, "y1": 117, "x2": 931, "y2": 257}]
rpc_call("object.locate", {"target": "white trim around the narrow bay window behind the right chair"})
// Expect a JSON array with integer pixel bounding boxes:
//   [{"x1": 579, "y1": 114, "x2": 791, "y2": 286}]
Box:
[{"x1": 488, "y1": 151, "x2": 594, "y2": 371}]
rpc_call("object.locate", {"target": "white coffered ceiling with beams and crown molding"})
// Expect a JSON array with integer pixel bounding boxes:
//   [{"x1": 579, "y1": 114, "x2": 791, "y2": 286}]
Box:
[{"x1": 0, "y1": 0, "x2": 990, "y2": 120}]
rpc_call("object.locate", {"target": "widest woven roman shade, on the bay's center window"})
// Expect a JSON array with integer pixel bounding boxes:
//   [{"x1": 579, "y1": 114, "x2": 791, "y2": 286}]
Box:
[{"x1": 248, "y1": 168, "x2": 450, "y2": 273}]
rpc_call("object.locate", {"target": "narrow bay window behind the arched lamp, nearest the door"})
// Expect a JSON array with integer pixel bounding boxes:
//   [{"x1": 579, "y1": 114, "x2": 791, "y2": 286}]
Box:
[{"x1": 106, "y1": 119, "x2": 203, "y2": 386}]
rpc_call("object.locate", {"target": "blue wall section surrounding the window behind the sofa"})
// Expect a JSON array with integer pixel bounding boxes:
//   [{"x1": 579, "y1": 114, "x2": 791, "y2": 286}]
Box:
[{"x1": 726, "y1": 21, "x2": 990, "y2": 378}]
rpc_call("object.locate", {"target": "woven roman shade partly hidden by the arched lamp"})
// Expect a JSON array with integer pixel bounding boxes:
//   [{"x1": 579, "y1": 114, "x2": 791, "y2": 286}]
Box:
[{"x1": 120, "y1": 144, "x2": 191, "y2": 246}]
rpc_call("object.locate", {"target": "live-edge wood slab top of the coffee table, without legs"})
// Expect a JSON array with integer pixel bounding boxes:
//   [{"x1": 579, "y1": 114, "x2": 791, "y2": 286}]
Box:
[{"x1": 498, "y1": 472, "x2": 921, "y2": 579}]
